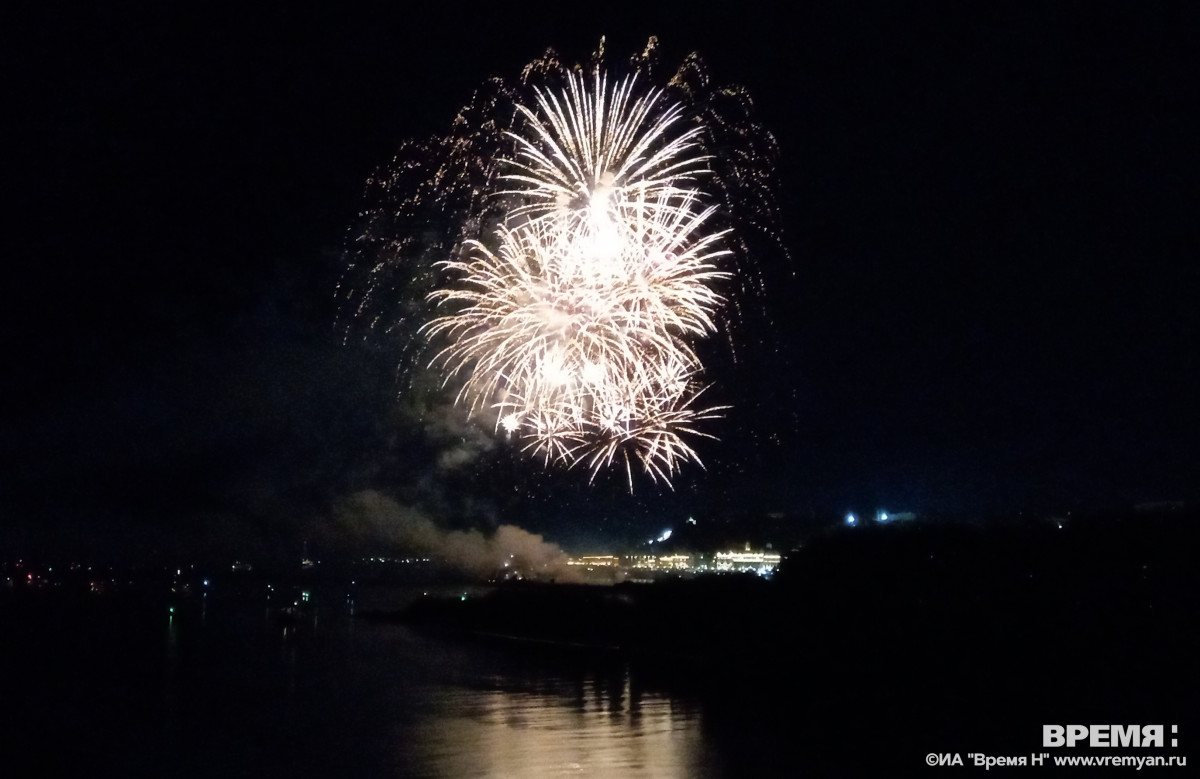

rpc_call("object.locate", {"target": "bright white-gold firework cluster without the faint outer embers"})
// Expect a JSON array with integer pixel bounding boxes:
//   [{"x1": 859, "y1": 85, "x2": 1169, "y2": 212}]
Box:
[{"x1": 425, "y1": 73, "x2": 728, "y2": 487}]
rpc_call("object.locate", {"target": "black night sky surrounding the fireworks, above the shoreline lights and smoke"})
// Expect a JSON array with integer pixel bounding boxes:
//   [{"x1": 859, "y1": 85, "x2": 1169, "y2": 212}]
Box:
[{"x1": 0, "y1": 2, "x2": 1200, "y2": 552}]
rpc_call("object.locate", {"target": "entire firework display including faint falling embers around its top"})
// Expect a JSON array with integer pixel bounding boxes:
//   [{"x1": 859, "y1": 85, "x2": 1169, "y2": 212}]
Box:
[{"x1": 348, "y1": 41, "x2": 787, "y2": 490}]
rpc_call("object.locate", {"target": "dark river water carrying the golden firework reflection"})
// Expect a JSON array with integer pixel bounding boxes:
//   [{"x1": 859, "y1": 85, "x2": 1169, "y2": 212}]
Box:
[{"x1": 0, "y1": 583, "x2": 792, "y2": 778}]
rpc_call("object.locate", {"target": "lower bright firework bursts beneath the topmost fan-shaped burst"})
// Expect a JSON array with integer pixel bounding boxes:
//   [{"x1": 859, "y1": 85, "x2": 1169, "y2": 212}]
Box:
[{"x1": 426, "y1": 184, "x2": 728, "y2": 478}]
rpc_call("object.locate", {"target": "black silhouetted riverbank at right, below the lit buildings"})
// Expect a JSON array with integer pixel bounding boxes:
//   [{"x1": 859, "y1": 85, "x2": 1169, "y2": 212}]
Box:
[{"x1": 394, "y1": 515, "x2": 1200, "y2": 767}]
